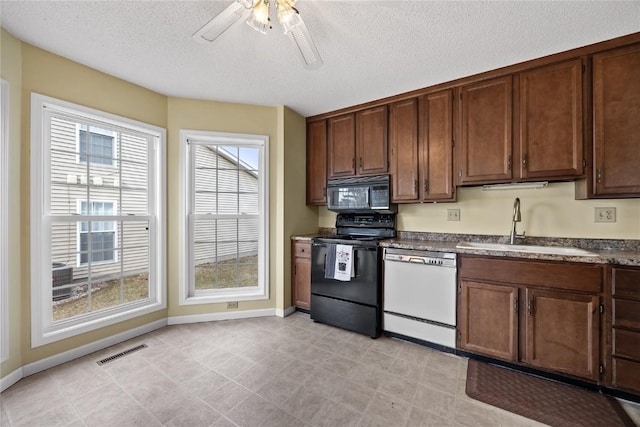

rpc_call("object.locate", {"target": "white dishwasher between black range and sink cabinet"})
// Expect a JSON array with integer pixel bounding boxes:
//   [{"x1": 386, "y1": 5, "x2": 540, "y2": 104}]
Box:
[{"x1": 383, "y1": 248, "x2": 457, "y2": 349}]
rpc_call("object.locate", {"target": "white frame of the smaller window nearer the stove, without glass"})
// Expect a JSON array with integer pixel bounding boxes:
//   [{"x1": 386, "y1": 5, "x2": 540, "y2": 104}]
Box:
[{"x1": 179, "y1": 129, "x2": 269, "y2": 305}]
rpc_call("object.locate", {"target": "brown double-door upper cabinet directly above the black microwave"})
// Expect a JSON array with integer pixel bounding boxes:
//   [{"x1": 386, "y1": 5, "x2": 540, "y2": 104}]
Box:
[{"x1": 328, "y1": 105, "x2": 389, "y2": 178}]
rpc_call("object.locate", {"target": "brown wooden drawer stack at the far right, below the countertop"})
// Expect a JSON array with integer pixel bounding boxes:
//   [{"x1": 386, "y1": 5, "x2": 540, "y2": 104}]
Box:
[{"x1": 610, "y1": 266, "x2": 640, "y2": 394}]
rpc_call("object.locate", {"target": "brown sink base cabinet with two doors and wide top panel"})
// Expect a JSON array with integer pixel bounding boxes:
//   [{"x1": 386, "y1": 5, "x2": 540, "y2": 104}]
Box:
[{"x1": 458, "y1": 255, "x2": 604, "y2": 382}]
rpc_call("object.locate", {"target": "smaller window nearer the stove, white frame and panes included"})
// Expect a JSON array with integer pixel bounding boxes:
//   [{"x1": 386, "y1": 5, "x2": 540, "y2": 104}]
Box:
[{"x1": 180, "y1": 130, "x2": 269, "y2": 304}]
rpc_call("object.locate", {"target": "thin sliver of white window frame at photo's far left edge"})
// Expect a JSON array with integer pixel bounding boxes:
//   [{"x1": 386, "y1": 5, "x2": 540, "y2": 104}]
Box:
[{"x1": 0, "y1": 79, "x2": 9, "y2": 363}]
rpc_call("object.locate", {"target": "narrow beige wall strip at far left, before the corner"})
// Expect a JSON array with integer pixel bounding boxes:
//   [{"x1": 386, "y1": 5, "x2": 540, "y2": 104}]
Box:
[{"x1": 0, "y1": 29, "x2": 23, "y2": 376}]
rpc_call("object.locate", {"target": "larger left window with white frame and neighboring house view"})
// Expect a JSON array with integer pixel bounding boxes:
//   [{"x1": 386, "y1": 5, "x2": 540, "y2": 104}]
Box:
[{"x1": 31, "y1": 94, "x2": 166, "y2": 347}]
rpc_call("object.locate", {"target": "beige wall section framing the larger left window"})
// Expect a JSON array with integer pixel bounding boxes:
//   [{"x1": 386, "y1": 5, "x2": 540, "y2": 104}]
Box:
[{"x1": 15, "y1": 43, "x2": 167, "y2": 366}]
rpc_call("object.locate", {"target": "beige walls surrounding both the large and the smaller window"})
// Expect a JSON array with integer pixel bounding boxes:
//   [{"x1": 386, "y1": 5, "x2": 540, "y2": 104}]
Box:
[{"x1": 0, "y1": 36, "x2": 318, "y2": 377}]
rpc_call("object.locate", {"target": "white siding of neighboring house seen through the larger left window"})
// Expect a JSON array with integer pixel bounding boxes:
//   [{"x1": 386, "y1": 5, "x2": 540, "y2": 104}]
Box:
[{"x1": 50, "y1": 117, "x2": 149, "y2": 282}]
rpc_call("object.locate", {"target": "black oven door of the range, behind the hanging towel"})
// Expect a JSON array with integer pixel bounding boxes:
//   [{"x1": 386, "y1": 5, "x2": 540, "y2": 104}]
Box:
[{"x1": 311, "y1": 242, "x2": 382, "y2": 308}]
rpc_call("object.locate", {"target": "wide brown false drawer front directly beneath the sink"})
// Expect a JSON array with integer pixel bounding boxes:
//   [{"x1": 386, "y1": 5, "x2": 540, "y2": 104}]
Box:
[{"x1": 460, "y1": 257, "x2": 603, "y2": 293}]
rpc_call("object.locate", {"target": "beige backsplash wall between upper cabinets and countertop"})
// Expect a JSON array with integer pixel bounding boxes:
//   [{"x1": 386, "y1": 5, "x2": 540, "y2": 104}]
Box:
[{"x1": 318, "y1": 182, "x2": 640, "y2": 239}]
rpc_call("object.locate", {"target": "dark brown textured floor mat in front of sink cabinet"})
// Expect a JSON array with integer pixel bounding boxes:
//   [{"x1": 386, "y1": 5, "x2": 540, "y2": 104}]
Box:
[{"x1": 467, "y1": 359, "x2": 635, "y2": 427}]
